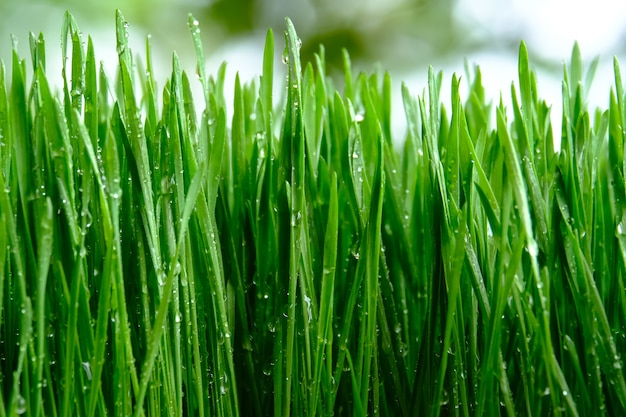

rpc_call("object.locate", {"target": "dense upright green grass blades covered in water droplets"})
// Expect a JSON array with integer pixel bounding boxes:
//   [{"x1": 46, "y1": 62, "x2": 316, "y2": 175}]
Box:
[{"x1": 0, "y1": 9, "x2": 626, "y2": 417}]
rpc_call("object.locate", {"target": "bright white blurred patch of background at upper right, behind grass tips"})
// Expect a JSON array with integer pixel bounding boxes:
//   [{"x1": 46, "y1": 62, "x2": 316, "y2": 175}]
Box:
[{"x1": 450, "y1": 0, "x2": 626, "y2": 114}]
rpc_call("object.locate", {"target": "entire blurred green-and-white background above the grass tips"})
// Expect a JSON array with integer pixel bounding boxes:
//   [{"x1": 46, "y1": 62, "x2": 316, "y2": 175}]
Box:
[{"x1": 0, "y1": 0, "x2": 626, "y2": 135}]
